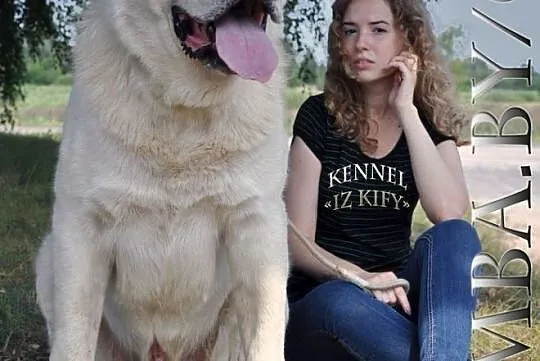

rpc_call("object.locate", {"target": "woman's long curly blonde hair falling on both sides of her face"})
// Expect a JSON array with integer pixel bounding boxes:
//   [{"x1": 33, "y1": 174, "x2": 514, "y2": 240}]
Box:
[{"x1": 324, "y1": 0, "x2": 466, "y2": 151}]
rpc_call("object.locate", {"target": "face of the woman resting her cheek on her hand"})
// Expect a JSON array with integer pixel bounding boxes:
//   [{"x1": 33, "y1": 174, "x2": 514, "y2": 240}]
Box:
[{"x1": 341, "y1": 0, "x2": 403, "y2": 83}]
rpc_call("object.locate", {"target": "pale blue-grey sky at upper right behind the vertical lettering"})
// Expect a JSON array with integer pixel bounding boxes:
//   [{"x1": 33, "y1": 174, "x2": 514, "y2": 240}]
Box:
[{"x1": 428, "y1": 0, "x2": 540, "y2": 69}]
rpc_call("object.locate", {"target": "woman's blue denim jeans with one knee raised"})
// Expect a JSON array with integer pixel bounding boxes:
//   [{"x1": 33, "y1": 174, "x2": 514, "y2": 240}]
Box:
[{"x1": 285, "y1": 219, "x2": 480, "y2": 361}]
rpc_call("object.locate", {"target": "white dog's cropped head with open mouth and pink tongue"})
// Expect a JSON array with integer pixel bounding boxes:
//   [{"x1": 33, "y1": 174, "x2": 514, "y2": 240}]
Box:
[{"x1": 86, "y1": 0, "x2": 282, "y2": 106}]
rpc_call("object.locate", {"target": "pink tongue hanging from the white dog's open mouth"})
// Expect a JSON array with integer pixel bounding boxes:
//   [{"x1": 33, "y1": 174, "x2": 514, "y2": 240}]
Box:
[{"x1": 216, "y1": 16, "x2": 278, "y2": 82}]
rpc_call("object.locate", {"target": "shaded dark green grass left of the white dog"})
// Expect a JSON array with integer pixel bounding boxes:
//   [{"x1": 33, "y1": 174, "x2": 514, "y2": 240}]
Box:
[{"x1": 0, "y1": 134, "x2": 58, "y2": 361}]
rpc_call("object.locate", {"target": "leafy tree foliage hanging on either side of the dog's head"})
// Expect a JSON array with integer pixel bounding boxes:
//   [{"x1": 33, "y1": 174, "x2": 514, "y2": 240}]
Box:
[{"x1": 0, "y1": 0, "x2": 437, "y2": 125}]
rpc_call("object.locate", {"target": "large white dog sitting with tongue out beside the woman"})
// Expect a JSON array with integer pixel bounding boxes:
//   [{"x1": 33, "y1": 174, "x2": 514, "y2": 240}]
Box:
[{"x1": 36, "y1": 0, "x2": 289, "y2": 361}]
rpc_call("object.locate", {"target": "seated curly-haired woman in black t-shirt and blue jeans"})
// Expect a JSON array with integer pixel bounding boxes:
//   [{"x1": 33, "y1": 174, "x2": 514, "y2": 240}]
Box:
[{"x1": 286, "y1": 0, "x2": 480, "y2": 361}]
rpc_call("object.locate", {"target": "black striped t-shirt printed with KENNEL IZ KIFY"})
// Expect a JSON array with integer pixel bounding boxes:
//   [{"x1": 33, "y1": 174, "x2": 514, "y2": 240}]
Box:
[{"x1": 289, "y1": 94, "x2": 451, "y2": 300}]
